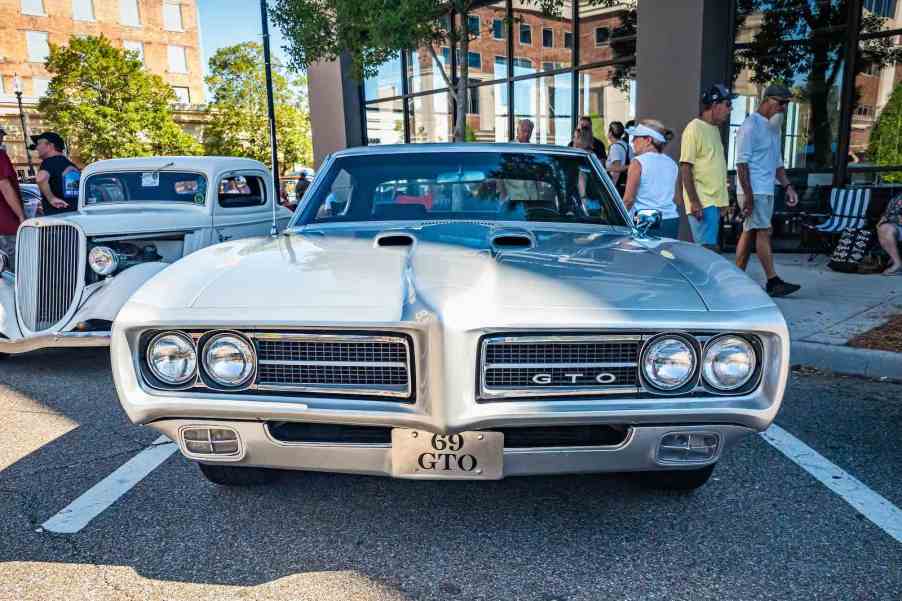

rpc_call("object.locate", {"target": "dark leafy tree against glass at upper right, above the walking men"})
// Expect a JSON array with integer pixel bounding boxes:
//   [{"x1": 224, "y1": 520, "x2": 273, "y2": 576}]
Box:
[{"x1": 735, "y1": 0, "x2": 902, "y2": 167}]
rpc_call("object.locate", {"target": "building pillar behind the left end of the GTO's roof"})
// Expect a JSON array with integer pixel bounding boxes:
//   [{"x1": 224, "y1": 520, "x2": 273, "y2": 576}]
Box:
[{"x1": 307, "y1": 56, "x2": 364, "y2": 169}]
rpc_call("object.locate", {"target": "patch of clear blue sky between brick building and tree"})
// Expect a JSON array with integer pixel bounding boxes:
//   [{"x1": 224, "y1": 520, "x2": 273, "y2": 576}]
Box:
[{"x1": 197, "y1": 0, "x2": 285, "y2": 74}]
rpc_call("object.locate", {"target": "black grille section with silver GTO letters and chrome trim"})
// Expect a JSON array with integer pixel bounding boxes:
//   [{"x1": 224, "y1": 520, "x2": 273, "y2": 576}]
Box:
[{"x1": 479, "y1": 335, "x2": 642, "y2": 400}]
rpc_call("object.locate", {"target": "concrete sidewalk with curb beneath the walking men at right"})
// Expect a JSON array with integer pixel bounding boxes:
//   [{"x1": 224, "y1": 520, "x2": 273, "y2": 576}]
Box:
[{"x1": 727, "y1": 254, "x2": 902, "y2": 379}]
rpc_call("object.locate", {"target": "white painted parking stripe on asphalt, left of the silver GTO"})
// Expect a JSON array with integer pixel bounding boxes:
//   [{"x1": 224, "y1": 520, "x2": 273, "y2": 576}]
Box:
[{"x1": 41, "y1": 436, "x2": 178, "y2": 534}]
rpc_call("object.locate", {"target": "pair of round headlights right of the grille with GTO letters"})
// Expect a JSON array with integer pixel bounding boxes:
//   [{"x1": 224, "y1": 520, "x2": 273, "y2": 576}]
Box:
[{"x1": 641, "y1": 333, "x2": 758, "y2": 394}]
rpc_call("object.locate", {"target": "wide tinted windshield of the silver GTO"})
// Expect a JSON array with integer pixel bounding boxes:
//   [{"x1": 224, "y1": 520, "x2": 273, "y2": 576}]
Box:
[{"x1": 297, "y1": 151, "x2": 626, "y2": 225}]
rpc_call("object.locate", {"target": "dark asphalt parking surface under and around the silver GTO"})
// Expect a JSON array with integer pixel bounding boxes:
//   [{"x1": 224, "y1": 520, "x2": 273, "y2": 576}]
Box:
[{"x1": 0, "y1": 349, "x2": 902, "y2": 601}]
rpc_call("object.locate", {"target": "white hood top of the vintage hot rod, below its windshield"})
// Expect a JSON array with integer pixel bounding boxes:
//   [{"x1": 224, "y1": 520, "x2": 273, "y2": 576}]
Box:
[{"x1": 54, "y1": 203, "x2": 212, "y2": 236}]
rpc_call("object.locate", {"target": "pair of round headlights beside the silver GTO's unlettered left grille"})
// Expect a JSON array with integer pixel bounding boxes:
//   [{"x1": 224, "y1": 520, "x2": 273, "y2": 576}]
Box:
[{"x1": 145, "y1": 332, "x2": 257, "y2": 390}]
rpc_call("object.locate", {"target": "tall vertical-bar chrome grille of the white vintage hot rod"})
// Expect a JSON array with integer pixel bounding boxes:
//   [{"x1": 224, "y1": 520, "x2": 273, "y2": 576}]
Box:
[{"x1": 16, "y1": 225, "x2": 81, "y2": 332}]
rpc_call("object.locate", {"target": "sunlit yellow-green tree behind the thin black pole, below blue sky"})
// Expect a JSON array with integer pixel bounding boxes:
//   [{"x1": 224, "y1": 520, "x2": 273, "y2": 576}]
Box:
[{"x1": 204, "y1": 42, "x2": 313, "y2": 174}]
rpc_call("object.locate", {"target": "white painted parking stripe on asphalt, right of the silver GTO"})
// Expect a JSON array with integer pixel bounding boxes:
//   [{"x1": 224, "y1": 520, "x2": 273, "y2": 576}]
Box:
[{"x1": 761, "y1": 424, "x2": 902, "y2": 543}]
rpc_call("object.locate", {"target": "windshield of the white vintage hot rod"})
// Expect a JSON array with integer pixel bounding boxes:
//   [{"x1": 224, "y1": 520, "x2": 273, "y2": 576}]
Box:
[{"x1": 84, "y1": 171, "x2": 207, "y2": 205}]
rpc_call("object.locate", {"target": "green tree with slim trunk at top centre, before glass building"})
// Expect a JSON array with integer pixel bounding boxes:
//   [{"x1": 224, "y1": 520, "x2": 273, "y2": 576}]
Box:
[{"x1": 272, "y1": 0, "x2": 635, "y2": 142}]
